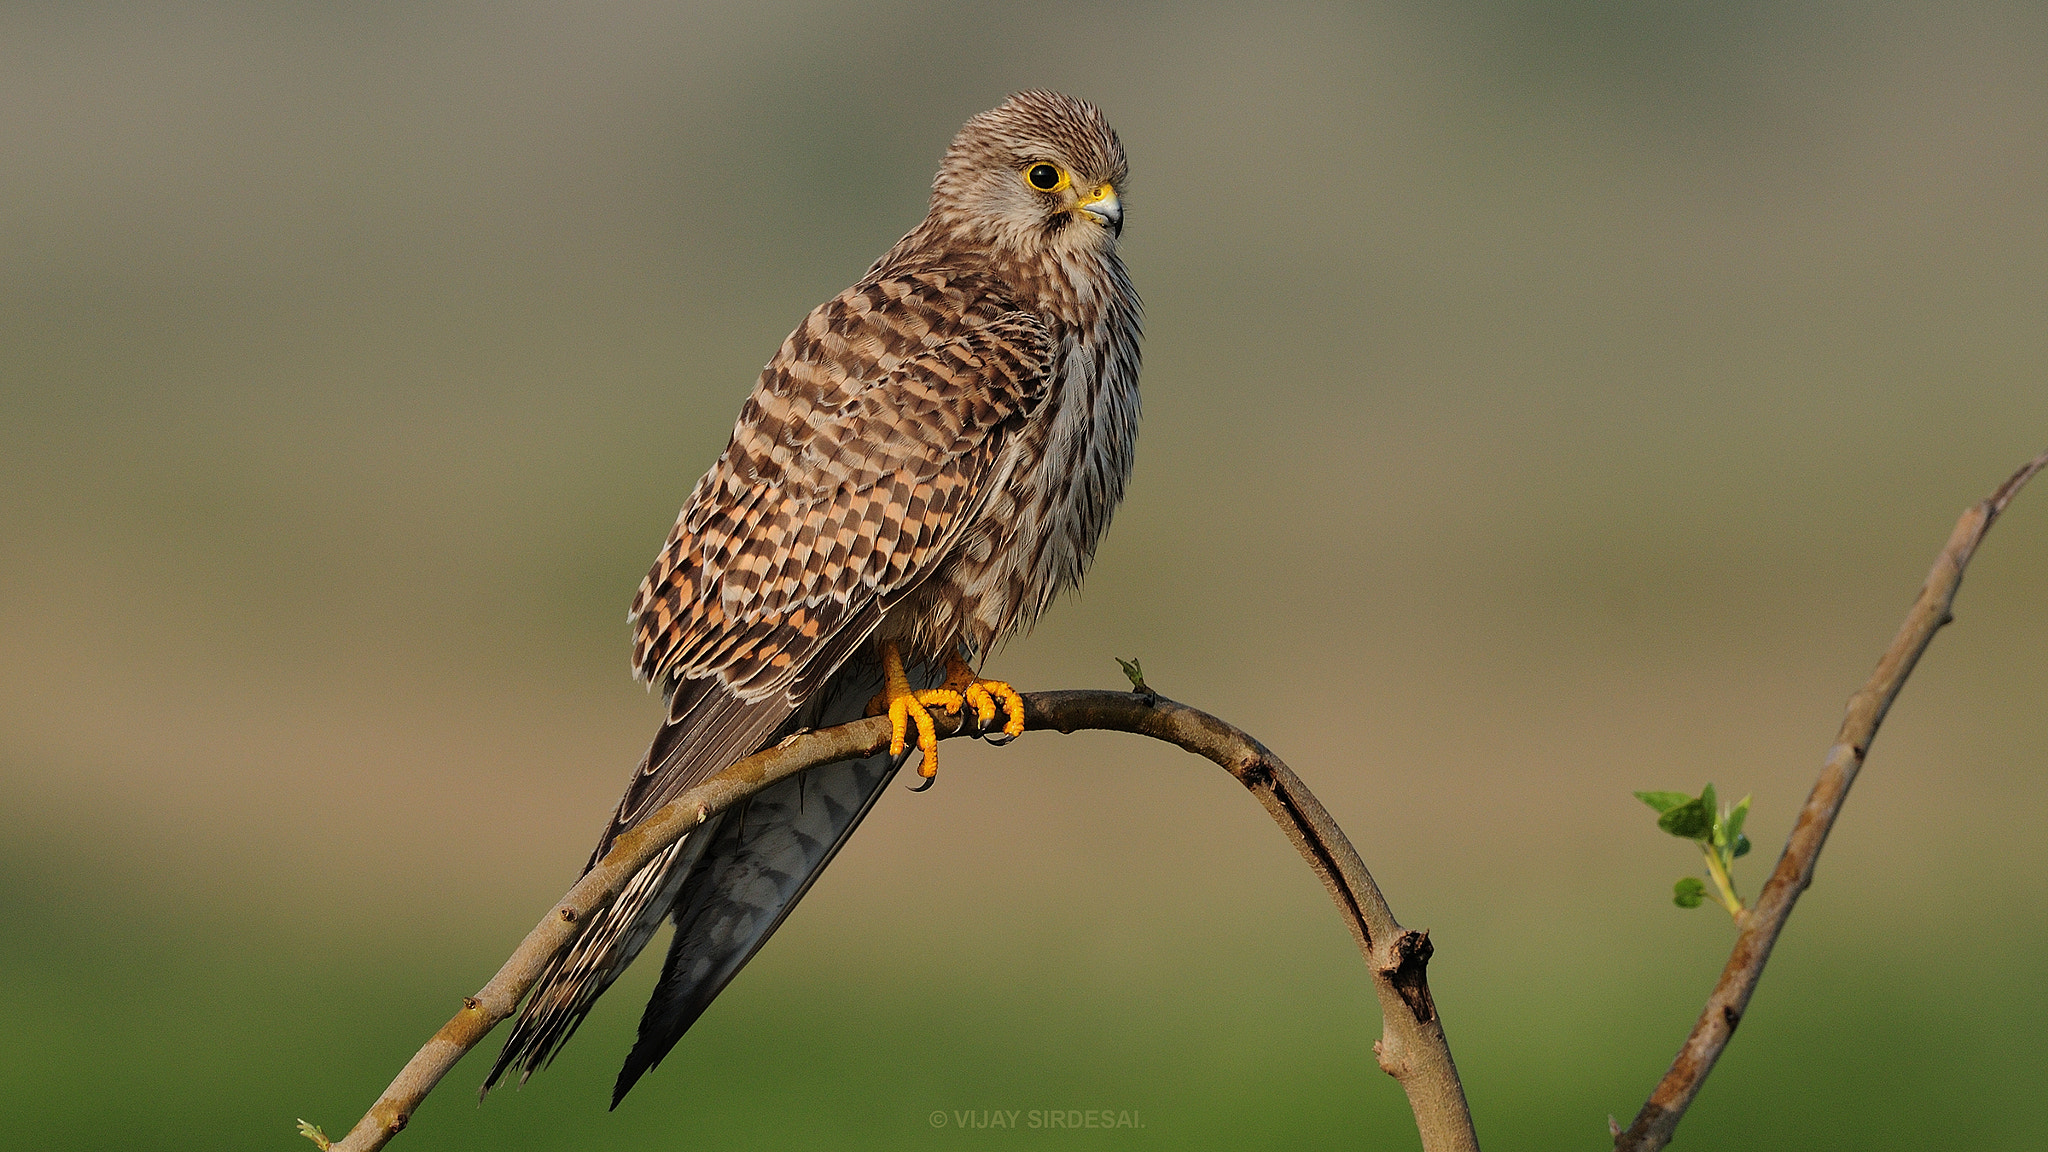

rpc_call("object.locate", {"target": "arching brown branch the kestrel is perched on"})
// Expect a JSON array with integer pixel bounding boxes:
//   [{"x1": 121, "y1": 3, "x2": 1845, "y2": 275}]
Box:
[{"x1": 301, "y1": 689, "x2": 1479, "y2": 1152}]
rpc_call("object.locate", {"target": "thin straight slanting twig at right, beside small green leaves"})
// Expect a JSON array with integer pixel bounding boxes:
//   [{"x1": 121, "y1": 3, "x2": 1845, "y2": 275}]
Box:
[{"x1": 1614, "y1": 451, "x2": 2048, "y2": 1152}]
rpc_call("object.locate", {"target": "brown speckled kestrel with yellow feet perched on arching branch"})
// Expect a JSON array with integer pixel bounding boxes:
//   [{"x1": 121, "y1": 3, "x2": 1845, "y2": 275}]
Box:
[{"x1": 483, "y1": 92, "x2": 1139, "y2": 1107}]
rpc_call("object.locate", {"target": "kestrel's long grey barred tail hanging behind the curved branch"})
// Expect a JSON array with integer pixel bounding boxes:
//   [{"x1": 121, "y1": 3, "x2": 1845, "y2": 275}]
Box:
[{"x1": 479, "y1": 660, "x2": 942, "y2": 1107}]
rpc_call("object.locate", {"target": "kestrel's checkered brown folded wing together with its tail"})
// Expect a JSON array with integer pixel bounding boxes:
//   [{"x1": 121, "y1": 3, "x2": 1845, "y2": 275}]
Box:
[{"x1": 483, "y1": 273, "x2": 1053, "y2": 1103}]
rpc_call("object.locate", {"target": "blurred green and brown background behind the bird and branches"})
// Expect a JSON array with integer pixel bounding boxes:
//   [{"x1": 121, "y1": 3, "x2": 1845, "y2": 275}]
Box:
[{"x1": 0, "y1": 0, "x2": 2048, "y2": 1150}]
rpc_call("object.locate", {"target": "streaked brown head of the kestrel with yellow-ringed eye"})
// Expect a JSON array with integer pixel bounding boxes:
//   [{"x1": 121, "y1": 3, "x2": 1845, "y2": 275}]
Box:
[{"x1": 932, "y1": 90, "x2": 1128, "y2": 256}]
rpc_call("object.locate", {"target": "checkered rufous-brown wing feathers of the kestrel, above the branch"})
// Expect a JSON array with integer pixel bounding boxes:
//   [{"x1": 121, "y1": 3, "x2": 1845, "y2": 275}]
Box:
[{"x1": 600, "y1": 281, "x2": 1053, "y2": 853}]
